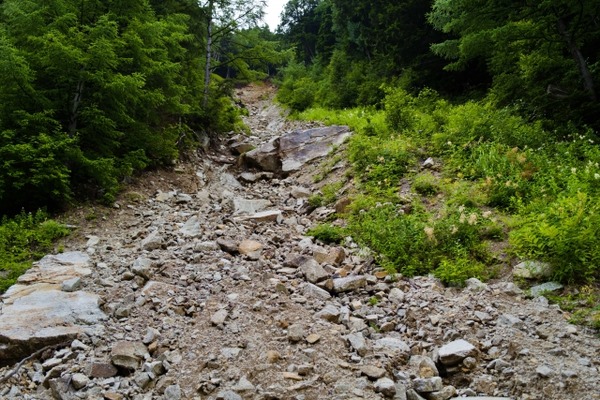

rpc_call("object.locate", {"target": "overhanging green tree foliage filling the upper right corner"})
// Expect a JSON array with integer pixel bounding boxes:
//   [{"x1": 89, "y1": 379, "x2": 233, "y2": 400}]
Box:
[{"x1": 428, "y1": 0, "x2": 600, "y2": 124}]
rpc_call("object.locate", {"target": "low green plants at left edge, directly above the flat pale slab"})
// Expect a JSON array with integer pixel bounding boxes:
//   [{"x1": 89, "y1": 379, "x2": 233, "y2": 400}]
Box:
[{"x1": 0, "y1": 211, "x2": 69, "y2": 293}]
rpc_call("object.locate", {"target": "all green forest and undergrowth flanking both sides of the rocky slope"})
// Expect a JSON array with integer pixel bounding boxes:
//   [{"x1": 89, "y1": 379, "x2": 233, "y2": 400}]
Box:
[{"x1": 0, "y1": 0, "x2": 600, "y2": 318}]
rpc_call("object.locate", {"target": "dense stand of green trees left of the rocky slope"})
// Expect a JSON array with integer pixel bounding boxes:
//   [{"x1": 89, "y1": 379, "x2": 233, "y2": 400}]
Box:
[{"x1": 0, "y1": 0, "x2": 289, "y2": 215}]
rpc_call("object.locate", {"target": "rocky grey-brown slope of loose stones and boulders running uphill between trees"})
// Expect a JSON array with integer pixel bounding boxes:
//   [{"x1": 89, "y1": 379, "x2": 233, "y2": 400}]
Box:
[{"x1": 0, "y1": 82, "x2": 600, "y2": 400}]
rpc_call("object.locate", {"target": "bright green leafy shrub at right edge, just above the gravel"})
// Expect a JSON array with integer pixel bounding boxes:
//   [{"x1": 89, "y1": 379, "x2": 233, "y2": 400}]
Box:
[{"x1": 510, "y1": 192, "x2": 600, "y2": 282}]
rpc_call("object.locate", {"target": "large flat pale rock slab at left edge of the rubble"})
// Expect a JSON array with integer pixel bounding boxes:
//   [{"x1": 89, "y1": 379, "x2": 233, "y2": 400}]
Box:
[{"x1": 0, "y1": 252, "x2": 106, "y2": 365}]
